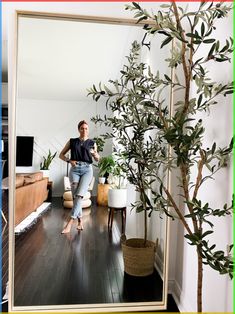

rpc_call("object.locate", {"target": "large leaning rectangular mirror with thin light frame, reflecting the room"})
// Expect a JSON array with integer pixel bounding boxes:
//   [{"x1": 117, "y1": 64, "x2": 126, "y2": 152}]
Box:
[{"x1": 9, "y1": 12, "x2": 171, "y2": 312}]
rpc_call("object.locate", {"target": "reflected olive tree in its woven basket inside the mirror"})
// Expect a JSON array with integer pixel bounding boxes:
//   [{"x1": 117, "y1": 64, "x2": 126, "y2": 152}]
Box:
[{"x1": 89, "y1": 42, "x2": 167, "y2": 276}]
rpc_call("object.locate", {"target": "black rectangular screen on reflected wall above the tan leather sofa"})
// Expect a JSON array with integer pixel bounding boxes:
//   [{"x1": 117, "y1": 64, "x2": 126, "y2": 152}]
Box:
[{"x1": 16, "y1": 136, "x2": 34, "y2": 167}]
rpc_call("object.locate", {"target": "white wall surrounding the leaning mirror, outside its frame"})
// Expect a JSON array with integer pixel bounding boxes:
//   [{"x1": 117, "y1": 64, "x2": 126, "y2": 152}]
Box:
[{"x1": 2, "y1": 2, "x2": 232, "y2": 312}]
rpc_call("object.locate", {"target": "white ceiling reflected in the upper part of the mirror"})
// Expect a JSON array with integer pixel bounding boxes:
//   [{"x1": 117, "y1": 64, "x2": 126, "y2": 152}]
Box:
[{"x1": 17, "y1": 17, "x2": 143, "y2": 101}]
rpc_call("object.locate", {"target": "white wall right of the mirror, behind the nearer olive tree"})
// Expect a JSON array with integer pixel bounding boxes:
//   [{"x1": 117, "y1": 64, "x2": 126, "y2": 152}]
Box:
[{"x1": 173, "y1": 4, "x2": 233, "y2": 312}]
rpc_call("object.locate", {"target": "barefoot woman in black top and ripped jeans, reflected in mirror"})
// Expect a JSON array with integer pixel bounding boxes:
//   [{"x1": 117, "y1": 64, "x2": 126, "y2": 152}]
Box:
[{"x1": 59, "y1": 120, "x2": 99, "y2": 233}]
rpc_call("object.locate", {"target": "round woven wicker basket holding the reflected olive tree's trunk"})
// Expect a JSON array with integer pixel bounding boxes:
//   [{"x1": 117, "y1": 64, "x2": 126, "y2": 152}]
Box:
[{"x1": 121, "y1": 237, "x2": 156, "y2": 277}]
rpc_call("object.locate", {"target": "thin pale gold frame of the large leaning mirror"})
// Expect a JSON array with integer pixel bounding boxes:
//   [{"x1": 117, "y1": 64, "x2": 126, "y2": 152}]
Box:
[{"x1": 9, "y1": 11, "x2": 172, "y2": 312}]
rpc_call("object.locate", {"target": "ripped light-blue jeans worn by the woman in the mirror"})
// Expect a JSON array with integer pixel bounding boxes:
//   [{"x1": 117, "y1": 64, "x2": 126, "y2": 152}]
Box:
[{"x1": 69, "y1": 161, "x2": 93, "y2": 219}]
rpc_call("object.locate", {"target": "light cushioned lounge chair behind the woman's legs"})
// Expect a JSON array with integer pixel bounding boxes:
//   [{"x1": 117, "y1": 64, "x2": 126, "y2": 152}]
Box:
[{"x1": 63, "y1": 177, "x2": 95, "y2": 208}]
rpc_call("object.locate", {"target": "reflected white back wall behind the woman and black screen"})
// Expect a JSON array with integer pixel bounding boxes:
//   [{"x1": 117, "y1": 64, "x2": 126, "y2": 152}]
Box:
[{"x1": 16, "y1": 99, "x2": 112, "y2": 196}]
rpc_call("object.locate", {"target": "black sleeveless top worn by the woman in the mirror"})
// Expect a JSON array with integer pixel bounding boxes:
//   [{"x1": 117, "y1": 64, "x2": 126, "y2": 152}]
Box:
[{"x1": 70, "y1": 137, "x2": 95, "y2": 164}]
